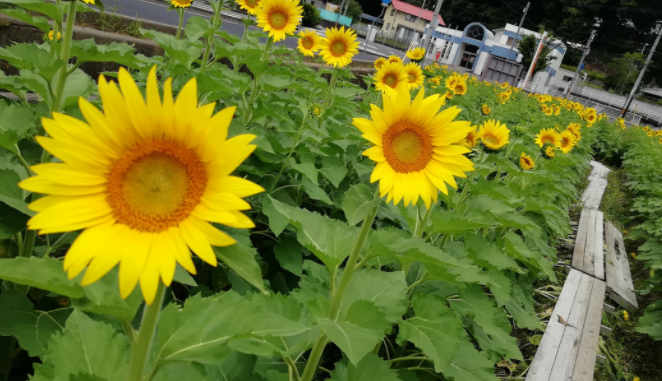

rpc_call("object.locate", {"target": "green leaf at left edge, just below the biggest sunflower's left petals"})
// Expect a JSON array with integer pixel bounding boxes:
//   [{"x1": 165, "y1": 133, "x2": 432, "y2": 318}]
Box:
[{"x1": 0, "y1": 257, "x2": 85, "y2": 298}]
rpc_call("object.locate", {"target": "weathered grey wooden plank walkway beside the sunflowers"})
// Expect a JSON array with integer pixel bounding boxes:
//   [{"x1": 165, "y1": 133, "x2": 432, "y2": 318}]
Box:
[{"x1": 526, "y1": 161, "x2": 637, "y2": 381}]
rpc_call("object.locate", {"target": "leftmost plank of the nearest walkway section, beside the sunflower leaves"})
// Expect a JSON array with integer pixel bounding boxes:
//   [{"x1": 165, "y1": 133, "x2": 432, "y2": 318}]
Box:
[{"x1": 526, "y1": 269, "x2": 582, "y2": 381}]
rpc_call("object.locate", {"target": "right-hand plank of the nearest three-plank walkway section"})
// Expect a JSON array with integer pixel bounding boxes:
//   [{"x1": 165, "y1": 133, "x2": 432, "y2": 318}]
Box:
[{"x1": 570, "y1": 280, "x2": 605, "y2": 381}]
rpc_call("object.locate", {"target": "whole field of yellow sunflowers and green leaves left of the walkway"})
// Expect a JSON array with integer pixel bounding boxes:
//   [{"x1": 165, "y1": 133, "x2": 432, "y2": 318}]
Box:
[{"x1": 0, "y1": 0, "x2": 644, "y2": 381}]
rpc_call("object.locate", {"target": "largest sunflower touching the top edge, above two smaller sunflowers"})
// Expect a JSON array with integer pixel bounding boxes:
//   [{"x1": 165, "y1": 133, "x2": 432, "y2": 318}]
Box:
[{"x1": 255, "y1": 0, "x2": 304, "y2": 42}]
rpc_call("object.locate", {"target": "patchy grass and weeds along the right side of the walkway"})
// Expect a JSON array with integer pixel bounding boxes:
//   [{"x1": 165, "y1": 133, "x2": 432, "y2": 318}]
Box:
[{"x1": 594, "y1": 168, "x2": 662, "y2": 381}]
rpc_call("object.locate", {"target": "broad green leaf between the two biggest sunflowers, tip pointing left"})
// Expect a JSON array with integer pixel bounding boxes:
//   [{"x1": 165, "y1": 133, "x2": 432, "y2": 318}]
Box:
[{"x1": 271, "y1": 198, "x2": 358, "y2": 271}]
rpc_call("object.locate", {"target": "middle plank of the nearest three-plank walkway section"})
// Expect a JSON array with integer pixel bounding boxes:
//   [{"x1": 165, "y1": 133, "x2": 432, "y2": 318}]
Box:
[{"x1": 549, "y1": 274, "x2": 595, "y2": 381}]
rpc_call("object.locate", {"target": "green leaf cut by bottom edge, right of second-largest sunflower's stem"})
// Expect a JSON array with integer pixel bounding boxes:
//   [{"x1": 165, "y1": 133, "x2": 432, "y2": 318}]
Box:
[{"x1": 329, "y1": 353, "x2": 400, "y2": 381}]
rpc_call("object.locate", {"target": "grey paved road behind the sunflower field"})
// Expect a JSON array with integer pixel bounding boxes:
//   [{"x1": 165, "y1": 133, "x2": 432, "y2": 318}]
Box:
[{"x1": 104, "y1": 0, "x2": 403, "y2": 61}]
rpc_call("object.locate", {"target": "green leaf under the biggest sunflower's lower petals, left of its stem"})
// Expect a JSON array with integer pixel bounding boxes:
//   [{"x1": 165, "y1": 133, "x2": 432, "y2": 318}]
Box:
[{"x1": 71, "y1": 269, "x2": 143, "y2": 322}]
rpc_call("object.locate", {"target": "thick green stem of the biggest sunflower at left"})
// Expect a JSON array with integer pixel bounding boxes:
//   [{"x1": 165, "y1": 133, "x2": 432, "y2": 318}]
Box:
[{"x1": 127, "y1": 282, "x2": 165, "y2": 381}]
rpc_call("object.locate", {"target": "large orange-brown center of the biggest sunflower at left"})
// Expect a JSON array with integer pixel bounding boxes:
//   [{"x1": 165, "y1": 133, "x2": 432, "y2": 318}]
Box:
[{"x1": 107, "y1": 140, "x2": 207, "y2": 232}]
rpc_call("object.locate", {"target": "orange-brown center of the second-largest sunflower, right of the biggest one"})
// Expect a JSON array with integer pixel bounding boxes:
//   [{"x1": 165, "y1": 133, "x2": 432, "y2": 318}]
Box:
[{"x1": 382, "y1": 121, "x2": 432, "y2": 173}]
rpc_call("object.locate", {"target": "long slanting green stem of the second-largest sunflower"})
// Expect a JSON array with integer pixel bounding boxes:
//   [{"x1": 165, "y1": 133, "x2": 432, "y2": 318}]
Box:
[{"x1": 301, "y1": 190, "x2": 379, "y2": 381}]
